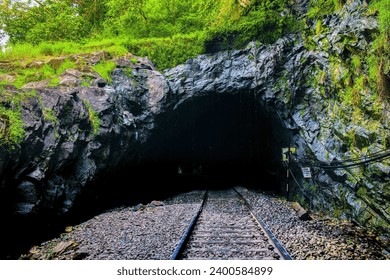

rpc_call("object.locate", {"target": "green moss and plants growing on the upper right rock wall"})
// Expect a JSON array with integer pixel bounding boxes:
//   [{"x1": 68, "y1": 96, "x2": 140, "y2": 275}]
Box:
[{"x1": 305, "y1": 0, "x2": 390, "y2": 147}]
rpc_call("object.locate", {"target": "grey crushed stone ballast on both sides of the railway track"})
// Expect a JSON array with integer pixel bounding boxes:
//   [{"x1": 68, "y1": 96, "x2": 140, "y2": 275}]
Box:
[{"x1": 20, "y1": 187, "x2": 390, "y2": 260}]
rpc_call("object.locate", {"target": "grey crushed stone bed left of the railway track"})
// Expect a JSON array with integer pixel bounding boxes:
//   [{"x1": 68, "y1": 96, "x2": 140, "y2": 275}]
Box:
[{"x1": 21, "y1": 191, "x2": 204, "y2": 260}]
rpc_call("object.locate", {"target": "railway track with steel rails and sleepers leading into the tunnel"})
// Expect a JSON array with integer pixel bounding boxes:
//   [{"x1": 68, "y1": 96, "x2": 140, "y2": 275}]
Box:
[{"x1": 171, "y1": 188, "x2": 291, "y2": 260}]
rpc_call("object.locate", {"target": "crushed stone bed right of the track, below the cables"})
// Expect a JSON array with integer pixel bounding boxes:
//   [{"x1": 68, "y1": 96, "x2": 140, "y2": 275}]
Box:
[{"x1": 237, "y1": 188, "x2": 390, "y2": 260}]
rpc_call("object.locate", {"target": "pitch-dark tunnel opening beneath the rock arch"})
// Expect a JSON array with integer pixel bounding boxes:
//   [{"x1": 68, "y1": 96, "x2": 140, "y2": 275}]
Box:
[{"x1": 76, "y1": 91, "x2": 288, "y2": 213}]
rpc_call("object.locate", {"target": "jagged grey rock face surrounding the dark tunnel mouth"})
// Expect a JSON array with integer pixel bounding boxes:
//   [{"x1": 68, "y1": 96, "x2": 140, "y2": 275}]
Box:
[{"x1": 0, "y1": 1, "x2": 390, "y2": 248}]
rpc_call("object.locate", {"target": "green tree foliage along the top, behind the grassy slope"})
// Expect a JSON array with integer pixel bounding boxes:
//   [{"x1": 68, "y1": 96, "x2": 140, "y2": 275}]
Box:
[{"x1": 0, "y1": 0, "x2": 292, "y2": 43}]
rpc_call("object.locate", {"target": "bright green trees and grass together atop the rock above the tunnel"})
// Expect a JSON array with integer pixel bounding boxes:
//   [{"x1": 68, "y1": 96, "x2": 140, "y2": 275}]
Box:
[{"x1": 0, "y1": 0, "x2": 293, "y2": 69}]
